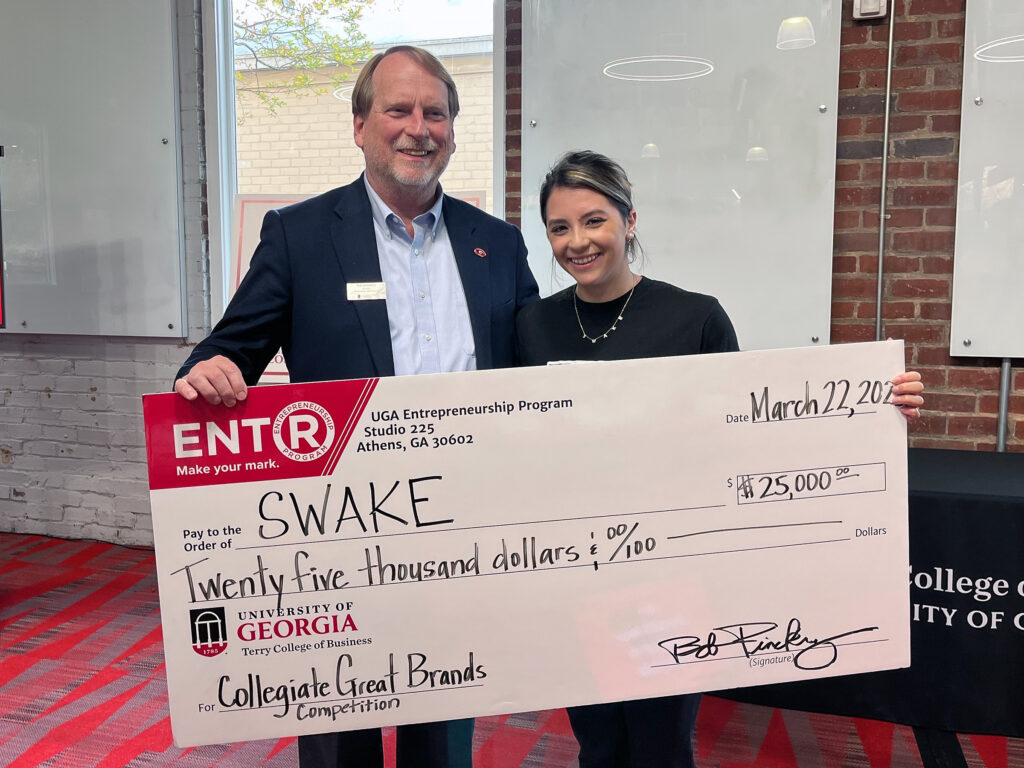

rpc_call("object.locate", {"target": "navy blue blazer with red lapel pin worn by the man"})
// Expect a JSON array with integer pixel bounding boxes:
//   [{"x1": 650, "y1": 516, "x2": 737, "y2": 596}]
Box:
[{"x1": 176, "y1": 177, "x2": 538, "y2": 385}]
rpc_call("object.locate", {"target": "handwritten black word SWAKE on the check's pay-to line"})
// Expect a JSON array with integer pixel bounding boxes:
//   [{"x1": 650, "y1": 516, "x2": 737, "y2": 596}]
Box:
[{"x1": 258, "y1": 475, "x2": 455, "y2": 540}]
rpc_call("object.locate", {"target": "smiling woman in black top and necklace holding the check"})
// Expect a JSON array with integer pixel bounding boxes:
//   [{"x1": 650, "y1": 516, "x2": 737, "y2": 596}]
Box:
[{"x1": 516, "y1": 152, "x2": 924, "y2": 768}]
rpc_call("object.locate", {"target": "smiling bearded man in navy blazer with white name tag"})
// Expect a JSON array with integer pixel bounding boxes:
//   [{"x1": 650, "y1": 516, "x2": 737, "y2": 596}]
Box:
[{"x1": 174, "y1": 46, "x2": 538, "y2": 768}]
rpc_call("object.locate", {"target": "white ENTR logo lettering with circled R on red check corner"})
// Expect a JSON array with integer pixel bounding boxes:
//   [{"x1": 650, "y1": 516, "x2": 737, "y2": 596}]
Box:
[{"x1": 173, "y1": 400, "x2": 335, "y2": 462}]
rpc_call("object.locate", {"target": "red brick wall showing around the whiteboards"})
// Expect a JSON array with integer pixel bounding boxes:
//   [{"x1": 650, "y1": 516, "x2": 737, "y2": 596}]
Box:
[{"x1": 505, "y1": 0, "x2": 1024, "y2": 452}]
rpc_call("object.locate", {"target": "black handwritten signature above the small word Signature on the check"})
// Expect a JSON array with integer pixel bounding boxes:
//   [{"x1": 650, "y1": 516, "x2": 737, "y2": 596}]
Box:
[{"x1": 658, "y1": 618, "x2": 879, "y2": 670}]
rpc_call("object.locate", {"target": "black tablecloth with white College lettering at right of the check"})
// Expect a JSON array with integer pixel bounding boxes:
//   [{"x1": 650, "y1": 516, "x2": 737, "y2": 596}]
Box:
[{"x1": 717, "y1": 452, "x2": 1024, "y2": 737}]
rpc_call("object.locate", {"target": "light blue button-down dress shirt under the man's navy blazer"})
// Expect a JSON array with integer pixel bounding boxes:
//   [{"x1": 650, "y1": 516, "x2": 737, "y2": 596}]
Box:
[{"x1": 364, "y1": 177, "x2": 476, "y2": 376}]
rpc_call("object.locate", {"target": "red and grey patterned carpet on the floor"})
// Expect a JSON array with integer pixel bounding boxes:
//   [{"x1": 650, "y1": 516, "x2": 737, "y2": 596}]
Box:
[{"x1": 0, "y1": 534, "x2": 1024, "y2": 768}]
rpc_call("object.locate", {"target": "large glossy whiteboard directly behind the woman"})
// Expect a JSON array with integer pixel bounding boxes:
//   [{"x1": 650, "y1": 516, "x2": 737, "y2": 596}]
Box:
[{"x1": 522, "y1": 0, "x2": 841, "y2": 349}]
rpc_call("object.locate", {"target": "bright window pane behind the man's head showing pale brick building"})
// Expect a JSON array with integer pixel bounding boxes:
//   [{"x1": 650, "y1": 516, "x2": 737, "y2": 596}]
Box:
[{"x1": 233, "y1": 0, "x2": 494, "y2": 211}]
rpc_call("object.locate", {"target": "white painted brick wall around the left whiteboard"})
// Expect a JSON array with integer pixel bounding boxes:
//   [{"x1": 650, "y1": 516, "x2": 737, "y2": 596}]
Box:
[{"x1": 0, "y1": 0, "x2": 207, "y2": 545}]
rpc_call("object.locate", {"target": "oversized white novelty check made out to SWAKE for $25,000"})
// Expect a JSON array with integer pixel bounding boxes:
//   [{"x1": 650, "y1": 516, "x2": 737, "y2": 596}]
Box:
[{"x1": 144, "y1": 342, "x2": 909, "y2": 745}]
